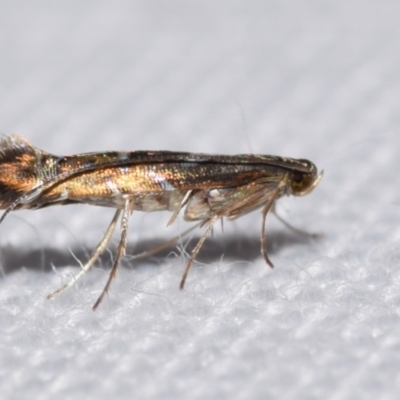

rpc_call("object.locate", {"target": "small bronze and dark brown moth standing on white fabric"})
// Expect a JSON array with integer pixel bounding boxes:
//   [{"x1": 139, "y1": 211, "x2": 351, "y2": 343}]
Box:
[{"x1": 0, "y1": 136, "x2": 322, "y2": 310}]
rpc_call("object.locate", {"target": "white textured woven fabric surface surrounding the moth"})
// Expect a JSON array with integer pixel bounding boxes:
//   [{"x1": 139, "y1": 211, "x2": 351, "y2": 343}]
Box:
[{"x1": 0, "y1": 0, "x2": 400, "y2": 400}]
